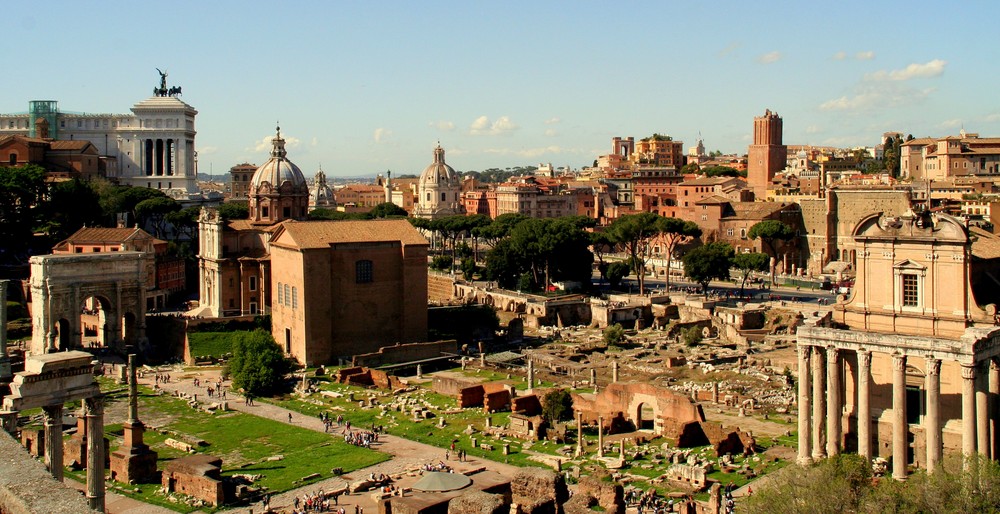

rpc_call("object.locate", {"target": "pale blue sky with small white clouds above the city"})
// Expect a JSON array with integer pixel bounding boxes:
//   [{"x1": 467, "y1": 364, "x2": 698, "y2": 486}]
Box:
[{"x1": 0, "y1": 0, "x2": 1000, "y2": 177}]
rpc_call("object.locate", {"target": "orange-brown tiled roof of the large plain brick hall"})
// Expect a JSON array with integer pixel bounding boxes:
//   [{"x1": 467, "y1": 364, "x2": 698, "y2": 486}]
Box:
[{"x1": 272, "y1": 219, "x2": 428, "y2": 249}]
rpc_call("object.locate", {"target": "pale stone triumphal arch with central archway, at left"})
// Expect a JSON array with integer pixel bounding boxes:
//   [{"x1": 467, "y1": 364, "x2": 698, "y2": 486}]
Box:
[{"x1": 30, "y1": 252, "x2": 147, "y2": 355}]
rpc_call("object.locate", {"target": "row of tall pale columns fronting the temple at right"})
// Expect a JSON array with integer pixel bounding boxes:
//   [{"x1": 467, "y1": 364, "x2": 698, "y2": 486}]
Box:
[{"x1": 798, "y1": 344, "x2": 1000, "y2": 479}]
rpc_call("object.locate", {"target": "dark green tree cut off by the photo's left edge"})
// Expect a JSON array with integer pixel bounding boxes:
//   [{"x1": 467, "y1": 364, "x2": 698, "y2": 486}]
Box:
[{"x1": 0, "y1": 165, "x2": 47, "y2": 261}]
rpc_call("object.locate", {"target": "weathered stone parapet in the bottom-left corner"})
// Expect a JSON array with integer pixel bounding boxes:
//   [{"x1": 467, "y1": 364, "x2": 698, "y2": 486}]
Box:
[{"x1": 0, "y1": 431, "x2": 97, "y2": 514}]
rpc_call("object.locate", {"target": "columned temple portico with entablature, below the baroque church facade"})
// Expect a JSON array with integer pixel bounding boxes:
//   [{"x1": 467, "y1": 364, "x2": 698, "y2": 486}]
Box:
[{"x1": 798, "y1": 327, "x2": 1000, "y2": 479}]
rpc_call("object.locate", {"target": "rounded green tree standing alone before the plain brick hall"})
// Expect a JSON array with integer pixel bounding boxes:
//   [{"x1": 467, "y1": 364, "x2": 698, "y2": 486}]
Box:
[{"x1": 226, "y1": 330, "x2": 292, "y2": 396}]
